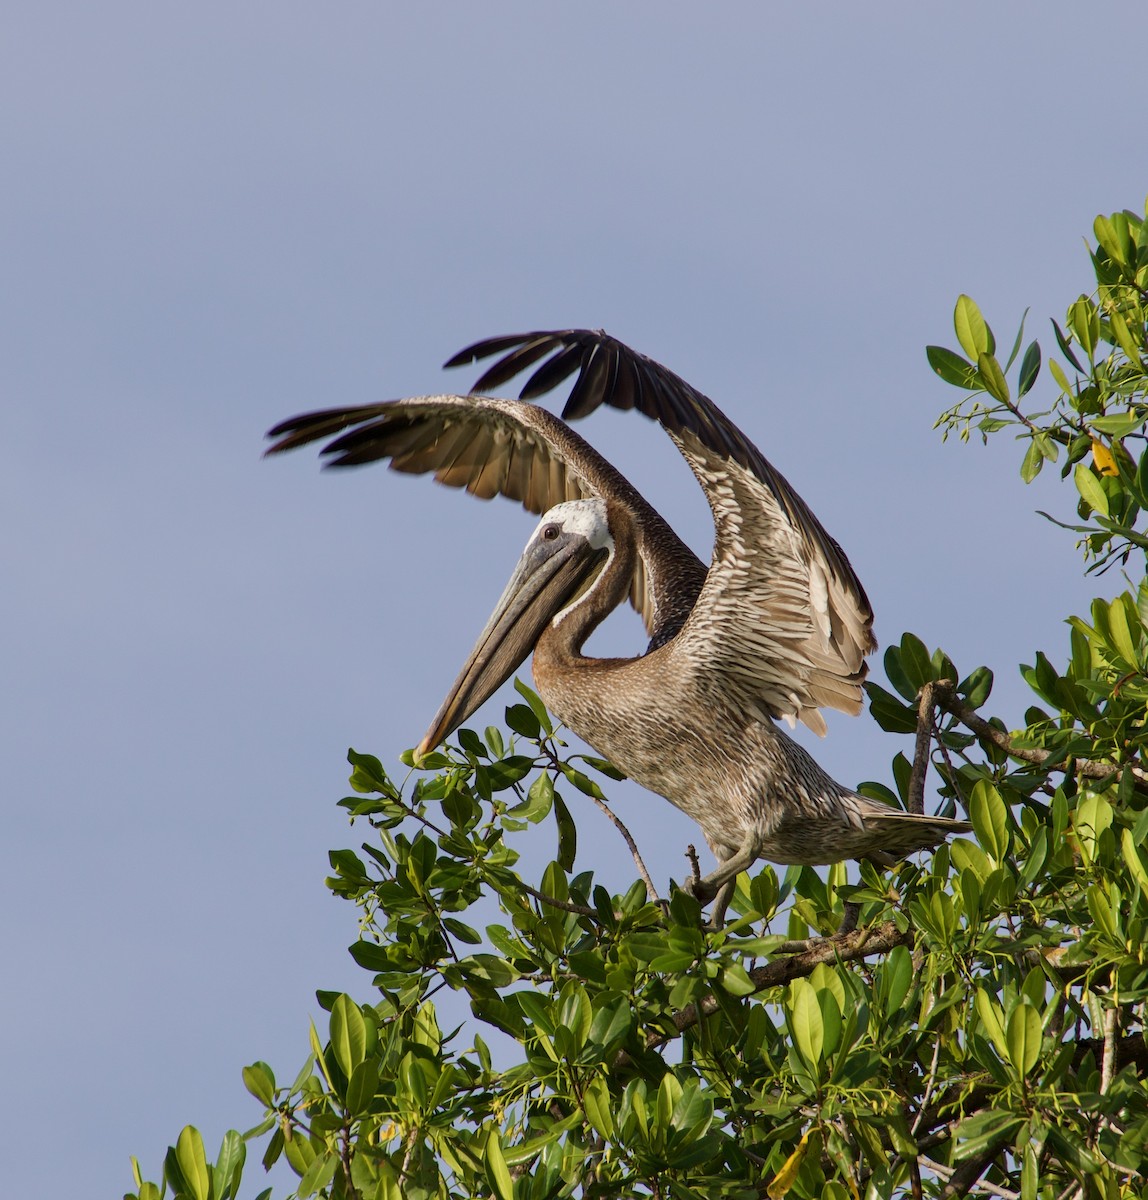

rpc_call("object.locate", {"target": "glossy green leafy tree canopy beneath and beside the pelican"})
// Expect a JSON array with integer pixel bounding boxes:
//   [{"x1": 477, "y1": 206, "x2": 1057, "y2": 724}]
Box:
[{"x1": 132, "y1": 201, "x2": 1148, "y2": 1200}]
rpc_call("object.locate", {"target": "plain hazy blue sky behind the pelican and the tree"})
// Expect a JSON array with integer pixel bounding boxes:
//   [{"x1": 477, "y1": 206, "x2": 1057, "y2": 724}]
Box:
[{"x1": 0, "y1": 0, "x2": 1148, "y2": 1196}]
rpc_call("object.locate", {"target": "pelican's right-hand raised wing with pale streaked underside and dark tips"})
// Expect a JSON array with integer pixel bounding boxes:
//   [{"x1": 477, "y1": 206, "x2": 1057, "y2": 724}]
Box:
[{"x1": 446, "y1": 329, "x2": 877, "y2": 733}]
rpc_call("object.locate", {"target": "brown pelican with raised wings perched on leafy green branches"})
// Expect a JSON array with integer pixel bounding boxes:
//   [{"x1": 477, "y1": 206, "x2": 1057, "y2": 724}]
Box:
[{"x1": 268, "y1": 330, "x2": 969, "y2": 899}]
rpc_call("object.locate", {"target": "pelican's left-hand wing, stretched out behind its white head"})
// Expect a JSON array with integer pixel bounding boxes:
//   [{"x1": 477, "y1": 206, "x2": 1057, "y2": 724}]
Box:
[{"x1": 266, "y1": 396, "x2": 705, "y2": 644}]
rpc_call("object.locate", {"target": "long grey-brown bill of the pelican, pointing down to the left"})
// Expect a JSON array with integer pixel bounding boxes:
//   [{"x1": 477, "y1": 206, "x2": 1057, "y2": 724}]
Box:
[{"x1": 415, "y1": 533, "x2": 607, "y2": 757}]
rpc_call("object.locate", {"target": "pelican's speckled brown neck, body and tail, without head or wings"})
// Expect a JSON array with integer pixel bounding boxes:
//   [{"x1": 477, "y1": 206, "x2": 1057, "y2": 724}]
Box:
[{"x1": 534, "y1": 496, "x2": 968, "y2": 864}]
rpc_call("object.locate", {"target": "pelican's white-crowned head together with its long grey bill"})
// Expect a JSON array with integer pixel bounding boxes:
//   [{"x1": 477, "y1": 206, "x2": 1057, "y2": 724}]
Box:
[{"x1": 415, "y1": 498, "x2": 614, "y2": 756}]
